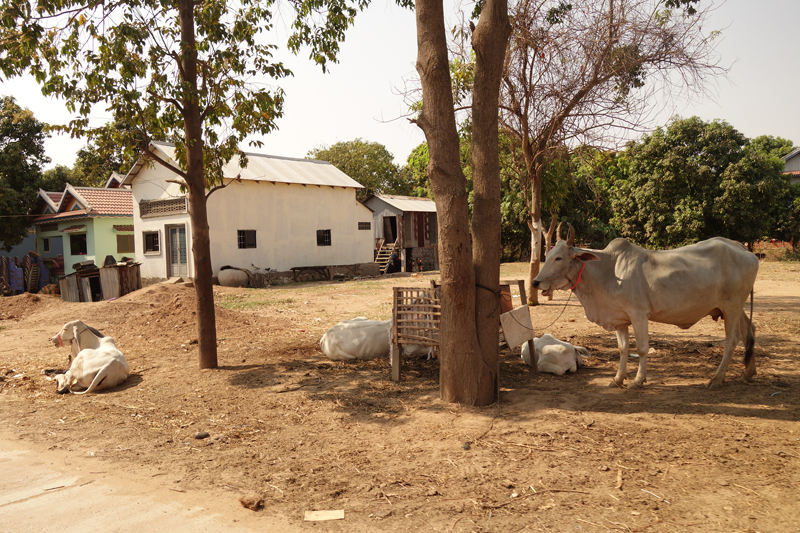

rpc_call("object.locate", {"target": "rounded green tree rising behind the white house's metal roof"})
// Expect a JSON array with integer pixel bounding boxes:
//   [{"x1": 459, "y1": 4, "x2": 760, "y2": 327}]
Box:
[{"x1": 307, "y1": 139, "x2": 412, "y2": 201}]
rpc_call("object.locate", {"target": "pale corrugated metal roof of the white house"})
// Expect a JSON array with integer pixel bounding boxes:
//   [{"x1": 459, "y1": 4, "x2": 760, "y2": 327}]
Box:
[{"x1": 145, "y1": 142, "x2": 364, "y2": 189}]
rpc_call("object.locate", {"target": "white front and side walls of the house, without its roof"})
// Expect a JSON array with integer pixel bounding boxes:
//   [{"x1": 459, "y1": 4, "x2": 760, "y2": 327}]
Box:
[{"x1": 132, "y1": 167, "x2": 374, "y2": 279}]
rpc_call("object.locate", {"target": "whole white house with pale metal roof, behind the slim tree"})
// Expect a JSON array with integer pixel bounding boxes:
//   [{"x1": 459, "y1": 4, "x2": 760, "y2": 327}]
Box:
[{"x1": 123, "y1": 142, "x2": 374, "y2": 278}]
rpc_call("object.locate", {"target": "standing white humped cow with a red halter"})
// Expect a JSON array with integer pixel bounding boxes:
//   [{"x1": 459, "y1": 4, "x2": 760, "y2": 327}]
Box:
[{"x1": 533, "y1": 225, "x2": 758, "y2": 388}]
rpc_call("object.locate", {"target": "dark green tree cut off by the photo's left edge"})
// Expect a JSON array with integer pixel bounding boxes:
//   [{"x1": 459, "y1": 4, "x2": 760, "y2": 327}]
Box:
[{"x1": 0, "y1": 96, "x2": 50, "y2": 252}]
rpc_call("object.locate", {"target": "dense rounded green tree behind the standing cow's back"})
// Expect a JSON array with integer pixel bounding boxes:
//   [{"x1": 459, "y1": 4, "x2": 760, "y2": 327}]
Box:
[{"x1": 610, "y1": 117, "x2": 789, "y2": 248}]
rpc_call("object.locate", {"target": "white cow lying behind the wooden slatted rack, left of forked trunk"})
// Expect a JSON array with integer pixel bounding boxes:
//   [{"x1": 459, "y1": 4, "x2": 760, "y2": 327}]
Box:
[{"x1": 319, "y1": 317, "x2": 429, "y2": 361}]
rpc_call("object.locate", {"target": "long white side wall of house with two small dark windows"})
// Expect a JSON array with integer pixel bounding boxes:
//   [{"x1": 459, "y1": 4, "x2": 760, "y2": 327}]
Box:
[{"x1": 208, "y1": 181, "x2": 374, "y2": 274}]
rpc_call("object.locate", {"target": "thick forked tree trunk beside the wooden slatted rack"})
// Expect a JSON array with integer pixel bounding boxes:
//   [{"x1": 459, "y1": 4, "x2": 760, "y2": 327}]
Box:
[{"x1": 416, "y1": 0, "x2": 508, "y2": 405}]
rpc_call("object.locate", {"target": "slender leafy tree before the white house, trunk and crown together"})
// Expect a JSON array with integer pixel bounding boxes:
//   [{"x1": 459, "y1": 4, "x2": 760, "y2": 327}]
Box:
[{"x1": 0, "y1": 0, "x2": 365, "y2": 368}]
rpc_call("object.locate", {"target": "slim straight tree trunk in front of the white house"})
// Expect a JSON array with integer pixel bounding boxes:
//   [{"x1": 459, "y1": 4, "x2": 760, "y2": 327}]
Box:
[{"x1": 178, "y1": 0, "x2": 217, "y2": 369}]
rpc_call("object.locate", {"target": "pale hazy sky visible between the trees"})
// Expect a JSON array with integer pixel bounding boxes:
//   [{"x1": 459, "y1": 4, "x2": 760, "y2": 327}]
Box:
[{"x1": 0, "y1": 0, "x2": 800, "y2": 168}]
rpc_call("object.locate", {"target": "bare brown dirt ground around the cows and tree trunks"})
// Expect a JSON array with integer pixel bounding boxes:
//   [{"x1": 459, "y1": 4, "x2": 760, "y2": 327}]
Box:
[{"x1": 0, "y1": 262, "x2": 800, "y2": 533}]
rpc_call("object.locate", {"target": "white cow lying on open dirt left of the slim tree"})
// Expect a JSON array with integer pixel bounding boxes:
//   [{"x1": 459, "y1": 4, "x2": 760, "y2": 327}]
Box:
[{"x1": 50, "y1": 320, "x2": 131, "y2": 394}]
